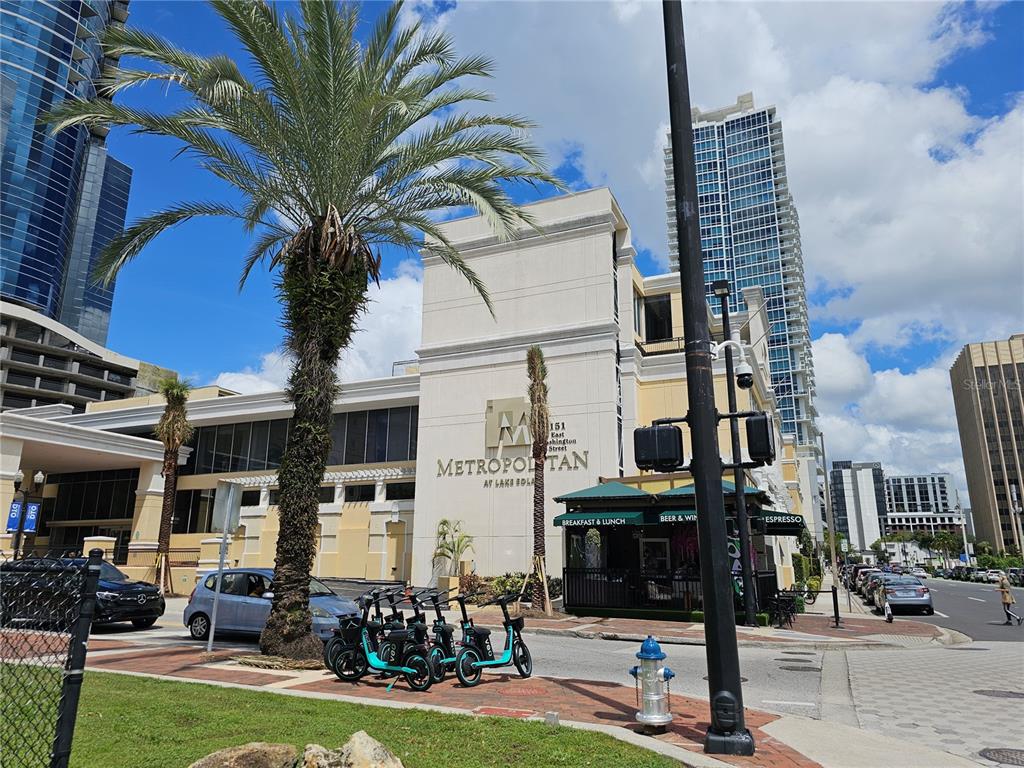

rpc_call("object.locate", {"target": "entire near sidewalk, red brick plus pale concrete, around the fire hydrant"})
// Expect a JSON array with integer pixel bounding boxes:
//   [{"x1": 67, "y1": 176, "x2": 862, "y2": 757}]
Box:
[{"x1": 68, "y1": 638, "x2": 973, "y2": 768}]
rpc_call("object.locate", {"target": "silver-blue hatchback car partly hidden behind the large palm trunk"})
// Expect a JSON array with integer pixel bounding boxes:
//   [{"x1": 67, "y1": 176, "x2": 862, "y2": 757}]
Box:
[{"x1": 183, "y1": 568, "x2": 358, "y2": 641}]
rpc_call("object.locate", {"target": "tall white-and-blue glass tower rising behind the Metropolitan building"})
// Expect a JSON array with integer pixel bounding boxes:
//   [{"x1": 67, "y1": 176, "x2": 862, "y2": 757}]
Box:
[{"x1": 666, "y1": 93, "x2": 817, "y2": 451}]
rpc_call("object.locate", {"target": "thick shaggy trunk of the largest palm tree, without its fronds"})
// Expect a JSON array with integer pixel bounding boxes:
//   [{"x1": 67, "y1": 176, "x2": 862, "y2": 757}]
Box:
[{"x1": 260, "y1": 254, "x2": 367, "y2": 658}]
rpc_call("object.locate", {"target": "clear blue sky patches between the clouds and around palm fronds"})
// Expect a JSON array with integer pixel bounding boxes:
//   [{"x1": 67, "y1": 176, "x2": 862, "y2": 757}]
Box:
[{"x1": 109, "y1": 2, "x2": 1024, "y2": 391}]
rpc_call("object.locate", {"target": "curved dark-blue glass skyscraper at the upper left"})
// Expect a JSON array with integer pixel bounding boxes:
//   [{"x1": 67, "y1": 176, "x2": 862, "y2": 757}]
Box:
[{"x1": 0, "y1": 0, "x2": 131, "y2": 344}]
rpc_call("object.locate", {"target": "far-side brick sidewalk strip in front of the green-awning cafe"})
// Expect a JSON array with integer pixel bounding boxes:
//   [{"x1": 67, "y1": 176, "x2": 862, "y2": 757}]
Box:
[{"x1": 460, "y1": 607, "x2": 941, "y2": 647}]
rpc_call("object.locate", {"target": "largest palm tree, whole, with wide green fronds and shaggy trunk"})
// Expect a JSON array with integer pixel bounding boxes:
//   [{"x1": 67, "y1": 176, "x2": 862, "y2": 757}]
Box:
[{"x1": 50, "y1": 0, "x2": 557, "y2": 657}]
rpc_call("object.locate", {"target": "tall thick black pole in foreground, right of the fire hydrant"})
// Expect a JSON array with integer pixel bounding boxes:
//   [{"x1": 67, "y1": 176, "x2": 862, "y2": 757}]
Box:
[{"x1": 662, "y1": 0, "x2": 754, "y2": 755}]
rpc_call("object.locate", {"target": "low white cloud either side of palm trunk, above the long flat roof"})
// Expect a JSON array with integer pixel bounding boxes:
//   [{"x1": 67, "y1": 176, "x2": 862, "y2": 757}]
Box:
[{"x1": 214, "y1": 260, "x2": 423, "y2": 394}]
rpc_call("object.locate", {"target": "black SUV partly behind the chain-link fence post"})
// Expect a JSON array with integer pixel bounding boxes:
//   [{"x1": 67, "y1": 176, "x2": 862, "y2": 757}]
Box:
[{"x1": 0, "y1": 557, "x2": 166, "y2": 629}]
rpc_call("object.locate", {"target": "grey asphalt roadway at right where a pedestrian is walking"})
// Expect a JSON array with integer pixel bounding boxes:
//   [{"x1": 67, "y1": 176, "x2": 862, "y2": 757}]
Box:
[{"x1": 884, "y1": 579, "x2": 1024, "y2": 643}]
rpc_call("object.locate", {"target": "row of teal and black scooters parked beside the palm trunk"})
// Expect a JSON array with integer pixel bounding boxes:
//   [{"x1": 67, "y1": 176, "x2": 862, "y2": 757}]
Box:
[{"x1": 324, "y1": 587, "x2": 534, "y2": 691}]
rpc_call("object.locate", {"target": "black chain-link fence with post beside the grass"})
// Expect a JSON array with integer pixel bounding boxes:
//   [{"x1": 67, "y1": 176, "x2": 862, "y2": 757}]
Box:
[{"x1": 0, "y1": 549, "x2": 102, "y2": 768}]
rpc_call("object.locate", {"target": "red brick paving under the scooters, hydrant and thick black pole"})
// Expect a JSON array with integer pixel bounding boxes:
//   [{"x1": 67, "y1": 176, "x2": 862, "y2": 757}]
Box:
[{"x1": 87, "y1": 645, "x2": 818, "y2": 768}]
